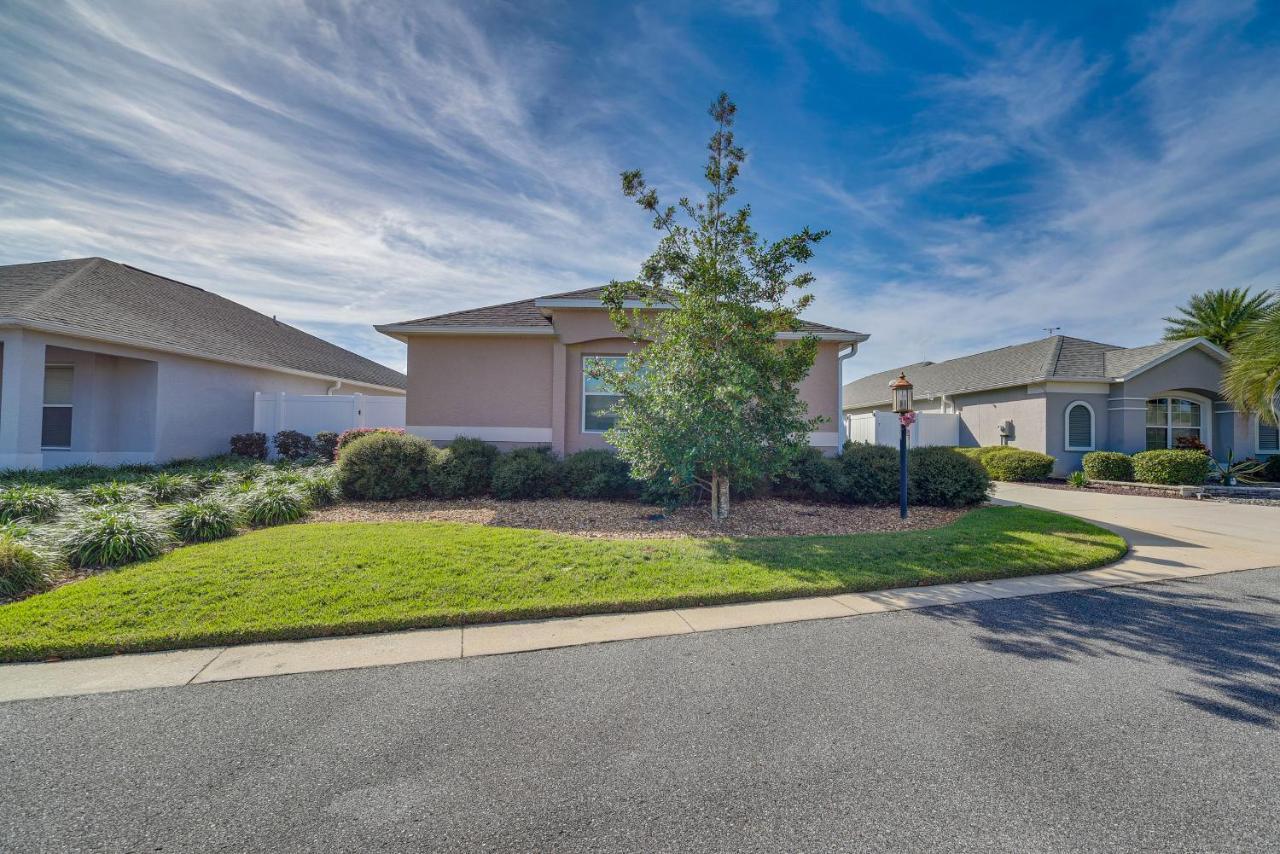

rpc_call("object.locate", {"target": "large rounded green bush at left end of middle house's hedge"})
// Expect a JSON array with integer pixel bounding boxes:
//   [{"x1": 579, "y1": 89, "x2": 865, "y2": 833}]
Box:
[{"x1": 338, "y1": 431, "x2": 440, "y2": 501}]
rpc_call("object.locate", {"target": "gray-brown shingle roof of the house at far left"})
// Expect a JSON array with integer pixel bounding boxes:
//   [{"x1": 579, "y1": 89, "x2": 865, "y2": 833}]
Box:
[{"x1": 0, "y1": 257, "x2": 404, "y2": 388}]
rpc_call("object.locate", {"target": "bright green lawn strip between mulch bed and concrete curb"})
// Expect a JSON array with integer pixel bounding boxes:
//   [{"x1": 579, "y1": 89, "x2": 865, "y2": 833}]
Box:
[{"x1": 0, "y1": 507, "x2": 1126, "y2": 661}]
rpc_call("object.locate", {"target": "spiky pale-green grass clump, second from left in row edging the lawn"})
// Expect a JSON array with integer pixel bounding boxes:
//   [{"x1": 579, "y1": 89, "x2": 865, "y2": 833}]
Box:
[{"x1": 52, "y1": 504, "x2": 172, "y2": 566}]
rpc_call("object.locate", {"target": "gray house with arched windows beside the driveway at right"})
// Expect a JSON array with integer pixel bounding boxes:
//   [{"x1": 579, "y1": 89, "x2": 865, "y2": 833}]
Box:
[{"x1": 844, "y1": 335, "x2": 1277, "y2": 474}]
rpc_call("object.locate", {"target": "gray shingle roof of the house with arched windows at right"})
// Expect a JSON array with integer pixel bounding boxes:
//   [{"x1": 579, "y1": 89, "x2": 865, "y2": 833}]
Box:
[{"x1": 844, "y1": 335, "x2": 1213, "y2": 408}]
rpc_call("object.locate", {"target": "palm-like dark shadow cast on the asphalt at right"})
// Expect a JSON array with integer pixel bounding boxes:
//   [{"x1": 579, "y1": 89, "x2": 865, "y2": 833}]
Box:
[{"x1": 920, "y1": 583, "x2": 1280, "y2": 729}]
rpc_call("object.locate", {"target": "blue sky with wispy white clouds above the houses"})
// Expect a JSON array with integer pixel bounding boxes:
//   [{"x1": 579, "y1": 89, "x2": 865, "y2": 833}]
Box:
[{"x1": 0, "y1": 0, "x2": 1280, "y2": 378}]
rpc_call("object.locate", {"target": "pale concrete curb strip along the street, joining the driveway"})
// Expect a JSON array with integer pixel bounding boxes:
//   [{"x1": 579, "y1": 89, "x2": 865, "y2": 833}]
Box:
[{"x1": 0, "y1": 484, "x2": 1280, "y2": 702}]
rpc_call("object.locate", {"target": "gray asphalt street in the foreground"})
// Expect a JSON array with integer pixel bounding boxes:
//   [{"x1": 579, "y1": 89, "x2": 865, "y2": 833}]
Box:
[{"x1": 0, "y1": 570, "x2": 1280, "y2": 853}]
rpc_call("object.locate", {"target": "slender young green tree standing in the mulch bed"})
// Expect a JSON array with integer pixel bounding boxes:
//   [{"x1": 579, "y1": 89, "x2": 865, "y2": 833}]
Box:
[{"x1": 590, "y1": 93, "x2": 827, "y2": 521}]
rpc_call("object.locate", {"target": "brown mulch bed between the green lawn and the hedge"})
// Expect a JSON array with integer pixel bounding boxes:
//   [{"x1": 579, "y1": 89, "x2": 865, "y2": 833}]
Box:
[{"x1": 310, "y1": 498, "x2": 966, "y2": 539}]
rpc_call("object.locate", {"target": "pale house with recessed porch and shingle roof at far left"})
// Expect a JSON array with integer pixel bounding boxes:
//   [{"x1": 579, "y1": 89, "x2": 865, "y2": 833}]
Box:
[{"x1": 0, "y1": 257, "x2": 404, "y2": 469}]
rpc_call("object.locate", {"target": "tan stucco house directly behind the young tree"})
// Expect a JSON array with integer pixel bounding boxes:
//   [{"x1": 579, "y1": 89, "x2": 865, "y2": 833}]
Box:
[{"x1": 378, "y1": 288, "x2": 867, "y2": 455}]
